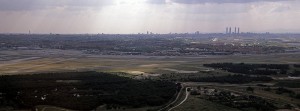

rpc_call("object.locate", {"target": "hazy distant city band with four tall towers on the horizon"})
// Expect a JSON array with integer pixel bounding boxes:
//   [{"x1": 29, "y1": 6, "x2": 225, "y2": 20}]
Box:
[{"x1": 0, "y1": 30, "x2": 300, "y2": 56}]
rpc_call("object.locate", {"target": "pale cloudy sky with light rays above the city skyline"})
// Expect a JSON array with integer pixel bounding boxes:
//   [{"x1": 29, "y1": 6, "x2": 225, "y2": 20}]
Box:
[{"x1": 0, "y1": 0, "x2": 300, "y2": 34}]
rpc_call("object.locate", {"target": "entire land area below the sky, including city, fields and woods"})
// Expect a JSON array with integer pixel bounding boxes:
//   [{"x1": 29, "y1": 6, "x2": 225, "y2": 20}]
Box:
[{"x1": 0, "y1": 31, "x2": 300, "y2": 111}]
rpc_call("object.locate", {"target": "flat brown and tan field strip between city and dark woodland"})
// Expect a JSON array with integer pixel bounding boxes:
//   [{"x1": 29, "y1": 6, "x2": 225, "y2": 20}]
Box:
[{"x1": 0, "y1": 50, "x2": 300, "y2": 75}]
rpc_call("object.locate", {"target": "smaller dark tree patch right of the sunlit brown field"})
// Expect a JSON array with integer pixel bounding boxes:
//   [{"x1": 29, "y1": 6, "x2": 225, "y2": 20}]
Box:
[{"x1": 203, "y1": 63, "x2": 289, "y2": 75}]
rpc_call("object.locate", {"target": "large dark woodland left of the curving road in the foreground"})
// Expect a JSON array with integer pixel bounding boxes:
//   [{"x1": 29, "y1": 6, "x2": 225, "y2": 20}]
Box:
[{"x1": 0, "y1": 72, "x2": 178, "y2": 110}]
